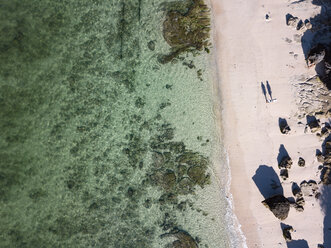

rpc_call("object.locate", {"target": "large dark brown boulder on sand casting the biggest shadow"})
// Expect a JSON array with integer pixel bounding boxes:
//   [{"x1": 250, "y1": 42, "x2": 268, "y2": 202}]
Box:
[{"x1": 262, "y1": 195, "x2": 290, "y2": 220}]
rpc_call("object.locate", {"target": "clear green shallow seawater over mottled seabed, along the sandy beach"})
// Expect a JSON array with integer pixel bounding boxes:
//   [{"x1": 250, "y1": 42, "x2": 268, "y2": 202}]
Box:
[{"x1": 0, "y1": 0, "x2": 233, "y2": 248}]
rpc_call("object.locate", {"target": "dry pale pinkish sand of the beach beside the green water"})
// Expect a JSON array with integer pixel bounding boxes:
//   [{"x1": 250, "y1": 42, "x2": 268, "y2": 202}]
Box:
[{"x1": 211, "y1": 0, "x2": 324, "y2": 248}]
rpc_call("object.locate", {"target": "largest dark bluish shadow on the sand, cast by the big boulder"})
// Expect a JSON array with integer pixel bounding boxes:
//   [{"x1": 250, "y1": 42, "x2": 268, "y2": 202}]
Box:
[{"x1": 252, "y1": 165, "x2": 283, "y2": 199}]
